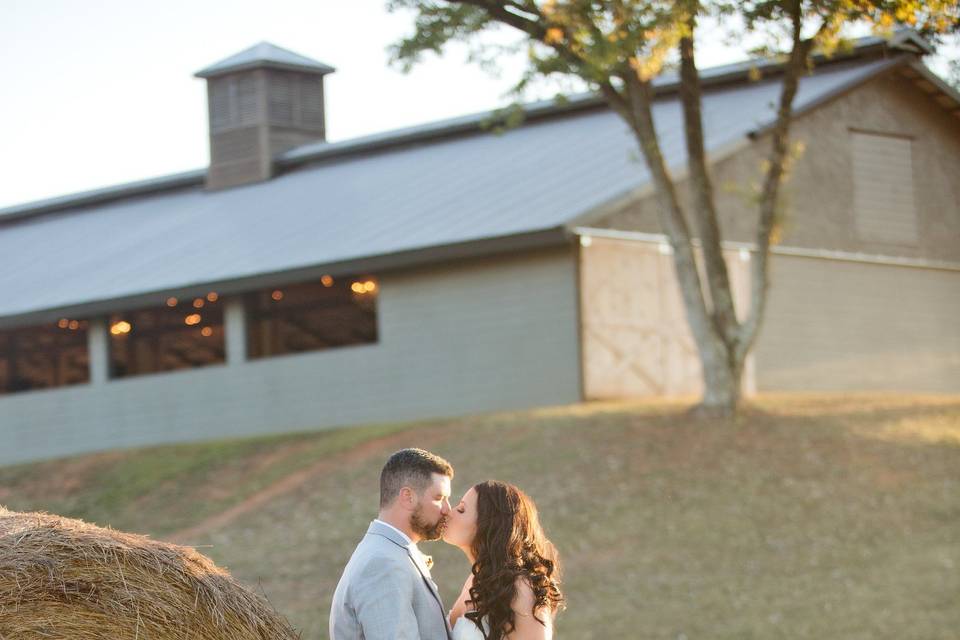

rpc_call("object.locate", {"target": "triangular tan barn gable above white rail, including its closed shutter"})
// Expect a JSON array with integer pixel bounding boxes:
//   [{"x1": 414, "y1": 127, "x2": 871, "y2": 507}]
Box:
[{"x1": 578, "y1": 60, "x2": 960, "y2": 263}]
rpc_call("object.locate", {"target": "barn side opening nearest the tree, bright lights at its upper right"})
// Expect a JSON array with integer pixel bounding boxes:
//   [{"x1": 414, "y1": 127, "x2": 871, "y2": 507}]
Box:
[{"x1": 246, "y1": 276, "x2": 378, "y2": 358}]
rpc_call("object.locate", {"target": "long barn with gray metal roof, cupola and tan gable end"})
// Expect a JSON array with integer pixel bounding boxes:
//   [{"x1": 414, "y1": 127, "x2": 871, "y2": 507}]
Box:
[{"x1": 0, "y1": 31, "x2": 960, "y2": 463}]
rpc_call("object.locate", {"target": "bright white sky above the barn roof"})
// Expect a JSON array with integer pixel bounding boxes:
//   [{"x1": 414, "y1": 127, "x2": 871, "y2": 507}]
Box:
[{"x1": 0, "y1": 0, "x2": 956, "y2": 207}]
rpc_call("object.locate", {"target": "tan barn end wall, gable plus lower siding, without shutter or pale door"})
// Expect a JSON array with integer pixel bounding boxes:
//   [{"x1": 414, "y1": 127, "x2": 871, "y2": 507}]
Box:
[{"x1": 584, "y1": 66, "x2": 960, "y2": 393}]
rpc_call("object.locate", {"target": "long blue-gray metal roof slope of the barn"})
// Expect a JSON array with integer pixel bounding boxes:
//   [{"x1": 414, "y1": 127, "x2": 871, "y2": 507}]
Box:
[{"x1": 0, "y1": 59, "x2": 900, "y2": 325}]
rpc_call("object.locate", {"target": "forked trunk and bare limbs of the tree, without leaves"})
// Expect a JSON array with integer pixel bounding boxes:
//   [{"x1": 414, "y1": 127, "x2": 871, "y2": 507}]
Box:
[{"x1": 492, "y1": 0, "x2": 812, "y2": 417}]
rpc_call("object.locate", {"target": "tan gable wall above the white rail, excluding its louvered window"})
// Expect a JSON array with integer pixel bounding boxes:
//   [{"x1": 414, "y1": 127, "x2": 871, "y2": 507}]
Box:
[{"x1": 586, "y1": 65, "x2": 960, "y2": 262}]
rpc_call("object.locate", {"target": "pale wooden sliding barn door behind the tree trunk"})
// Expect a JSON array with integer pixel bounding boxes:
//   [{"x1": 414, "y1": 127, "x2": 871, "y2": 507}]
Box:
[{"x1": 580, "y1": 232, "x2": 753, "y2": 400}]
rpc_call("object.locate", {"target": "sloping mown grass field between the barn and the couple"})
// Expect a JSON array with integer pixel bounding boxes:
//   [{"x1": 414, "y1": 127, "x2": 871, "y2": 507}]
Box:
[{"x1": 0, "y1": 395, "x2": 960, "y2": 640}]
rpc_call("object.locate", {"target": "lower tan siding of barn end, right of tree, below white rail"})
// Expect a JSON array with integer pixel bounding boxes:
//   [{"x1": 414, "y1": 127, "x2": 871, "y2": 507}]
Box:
[{"x1": 755, "y1": 255, "x2": 960, "y2": 393}]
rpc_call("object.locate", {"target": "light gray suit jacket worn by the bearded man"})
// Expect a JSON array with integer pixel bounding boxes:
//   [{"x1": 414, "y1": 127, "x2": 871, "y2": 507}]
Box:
[{"x1": 330, "y1": 522, "x2": 450, "y2": 640}]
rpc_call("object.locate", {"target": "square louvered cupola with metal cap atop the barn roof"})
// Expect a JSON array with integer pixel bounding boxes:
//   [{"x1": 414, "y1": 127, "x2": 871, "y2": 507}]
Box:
[{"x1": 194, "y1": 42, "x2": 334, "y2": 190}]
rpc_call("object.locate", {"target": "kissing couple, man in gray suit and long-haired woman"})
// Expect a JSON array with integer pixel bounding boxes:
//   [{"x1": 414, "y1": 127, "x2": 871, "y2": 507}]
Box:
[{"x1": 330, "y1": 449, "x2": 564, "y2": 640}]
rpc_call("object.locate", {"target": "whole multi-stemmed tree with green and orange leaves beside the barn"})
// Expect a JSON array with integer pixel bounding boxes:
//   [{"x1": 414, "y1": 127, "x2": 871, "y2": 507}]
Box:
[{"x1": 388, "y1": 0, "x2": 960, "y2": 416}]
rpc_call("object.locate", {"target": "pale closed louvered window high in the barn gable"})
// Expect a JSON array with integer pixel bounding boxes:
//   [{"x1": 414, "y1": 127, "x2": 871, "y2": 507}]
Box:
[{"x1": 851, "y1": 131, "x2": 917, "y2": 244}]
